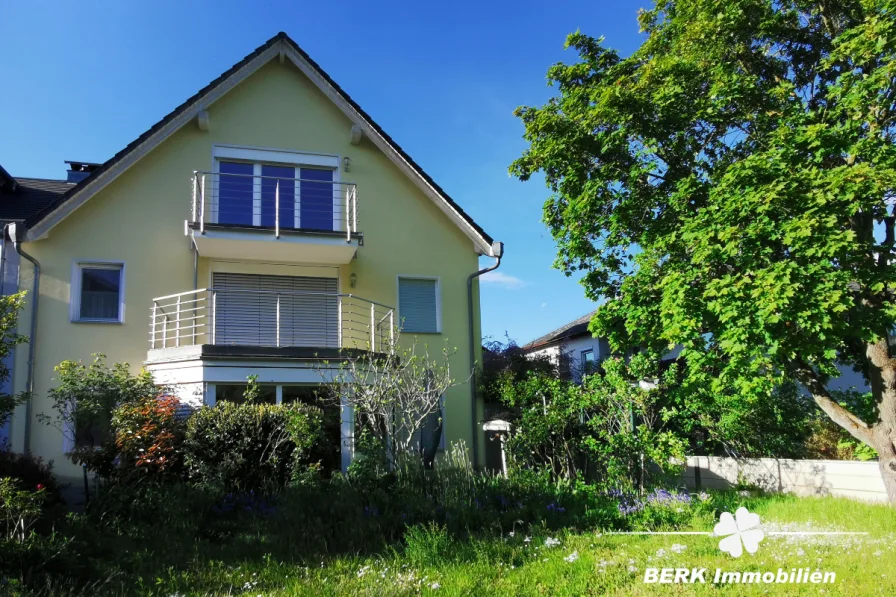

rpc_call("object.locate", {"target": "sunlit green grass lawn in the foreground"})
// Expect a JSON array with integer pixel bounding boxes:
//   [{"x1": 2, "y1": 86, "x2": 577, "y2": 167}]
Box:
[{"x1": 133, "y1": 497, "x2": 896, "y2": 596}]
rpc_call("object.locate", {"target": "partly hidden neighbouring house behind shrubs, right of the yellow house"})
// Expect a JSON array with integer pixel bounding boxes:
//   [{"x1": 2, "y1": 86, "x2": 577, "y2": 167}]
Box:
[{"x1": 523, "y1": 311, "x2": 610, "y2": 381}]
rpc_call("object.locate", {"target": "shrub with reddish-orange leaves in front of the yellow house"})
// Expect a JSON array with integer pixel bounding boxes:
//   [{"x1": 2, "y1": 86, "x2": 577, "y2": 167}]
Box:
[{"x1": 112, "y1": 396, "x2": 186, "y2": 478}]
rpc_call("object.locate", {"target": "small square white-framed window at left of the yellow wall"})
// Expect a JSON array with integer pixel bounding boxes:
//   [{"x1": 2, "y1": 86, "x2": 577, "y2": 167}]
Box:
[{"x1": 71, "y1": 263, "x2": 124, "y2": 323}]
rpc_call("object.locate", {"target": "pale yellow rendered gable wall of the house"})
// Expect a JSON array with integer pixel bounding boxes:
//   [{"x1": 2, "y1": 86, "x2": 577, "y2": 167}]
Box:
[{"x1": 11, "y1": 54, "x2": 490, "y2": 484}]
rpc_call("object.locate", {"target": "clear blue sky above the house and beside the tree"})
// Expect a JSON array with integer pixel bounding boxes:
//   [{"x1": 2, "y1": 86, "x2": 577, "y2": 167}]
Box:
[{"x1": 0, "y1": 0, "x2": 647, "y2": 343}]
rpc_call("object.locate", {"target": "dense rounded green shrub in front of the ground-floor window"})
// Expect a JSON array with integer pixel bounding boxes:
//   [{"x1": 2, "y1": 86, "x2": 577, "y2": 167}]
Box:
[{"x1": 184, "y1": 402, "x2": 322, "y2": 491}]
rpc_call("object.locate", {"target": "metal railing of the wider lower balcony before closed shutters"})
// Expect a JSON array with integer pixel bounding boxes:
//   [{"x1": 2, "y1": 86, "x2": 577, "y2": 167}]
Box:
[{"x1": 149, "y1": 288, "x2": 395, "y2": 351}]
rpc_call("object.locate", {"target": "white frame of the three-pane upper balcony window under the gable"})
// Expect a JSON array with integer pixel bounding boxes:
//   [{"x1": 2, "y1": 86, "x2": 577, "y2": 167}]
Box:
[{"x1": 211, "y1": 145, "x2": 345, "y2": 232}]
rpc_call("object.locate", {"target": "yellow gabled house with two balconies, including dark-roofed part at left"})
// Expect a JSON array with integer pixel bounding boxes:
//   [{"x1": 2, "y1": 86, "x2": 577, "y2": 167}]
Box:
[{"x1": 0, "y1": 33, "x2": 503, "y2": 477}]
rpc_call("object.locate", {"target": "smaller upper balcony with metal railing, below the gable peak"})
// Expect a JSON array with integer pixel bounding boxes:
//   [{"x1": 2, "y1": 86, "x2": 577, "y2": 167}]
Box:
[{"x1": 185, "y1": 168, "x2": 363, "y2": 264}]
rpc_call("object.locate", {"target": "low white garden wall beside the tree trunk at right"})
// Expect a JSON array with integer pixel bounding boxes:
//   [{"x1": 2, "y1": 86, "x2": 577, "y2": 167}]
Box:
[{"x1": 684, "y1": 456, "x2": 887, "y2": 502}]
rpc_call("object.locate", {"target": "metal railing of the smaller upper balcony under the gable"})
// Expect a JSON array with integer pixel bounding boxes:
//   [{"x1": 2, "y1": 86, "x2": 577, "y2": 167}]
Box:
[{"x1": 191, "y1": 170, "x2": 358, "y2": 241}]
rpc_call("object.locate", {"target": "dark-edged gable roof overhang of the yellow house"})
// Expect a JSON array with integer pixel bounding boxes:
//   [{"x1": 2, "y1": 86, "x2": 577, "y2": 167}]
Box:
[{"x1": 25, "y1": 31, "x2": 498, "y2": 256}]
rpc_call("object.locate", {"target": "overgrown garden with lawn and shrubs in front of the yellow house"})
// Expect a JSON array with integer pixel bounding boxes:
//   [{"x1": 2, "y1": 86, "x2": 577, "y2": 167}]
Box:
[{"x1": 0, "y1": 338, "x2": 896, "y2": 595}]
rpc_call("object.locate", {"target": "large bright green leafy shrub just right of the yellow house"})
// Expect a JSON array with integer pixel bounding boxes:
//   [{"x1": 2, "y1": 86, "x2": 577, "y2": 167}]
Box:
[{"x1": 502, "y1": 357, "x2": 684, "y2": 489}]
